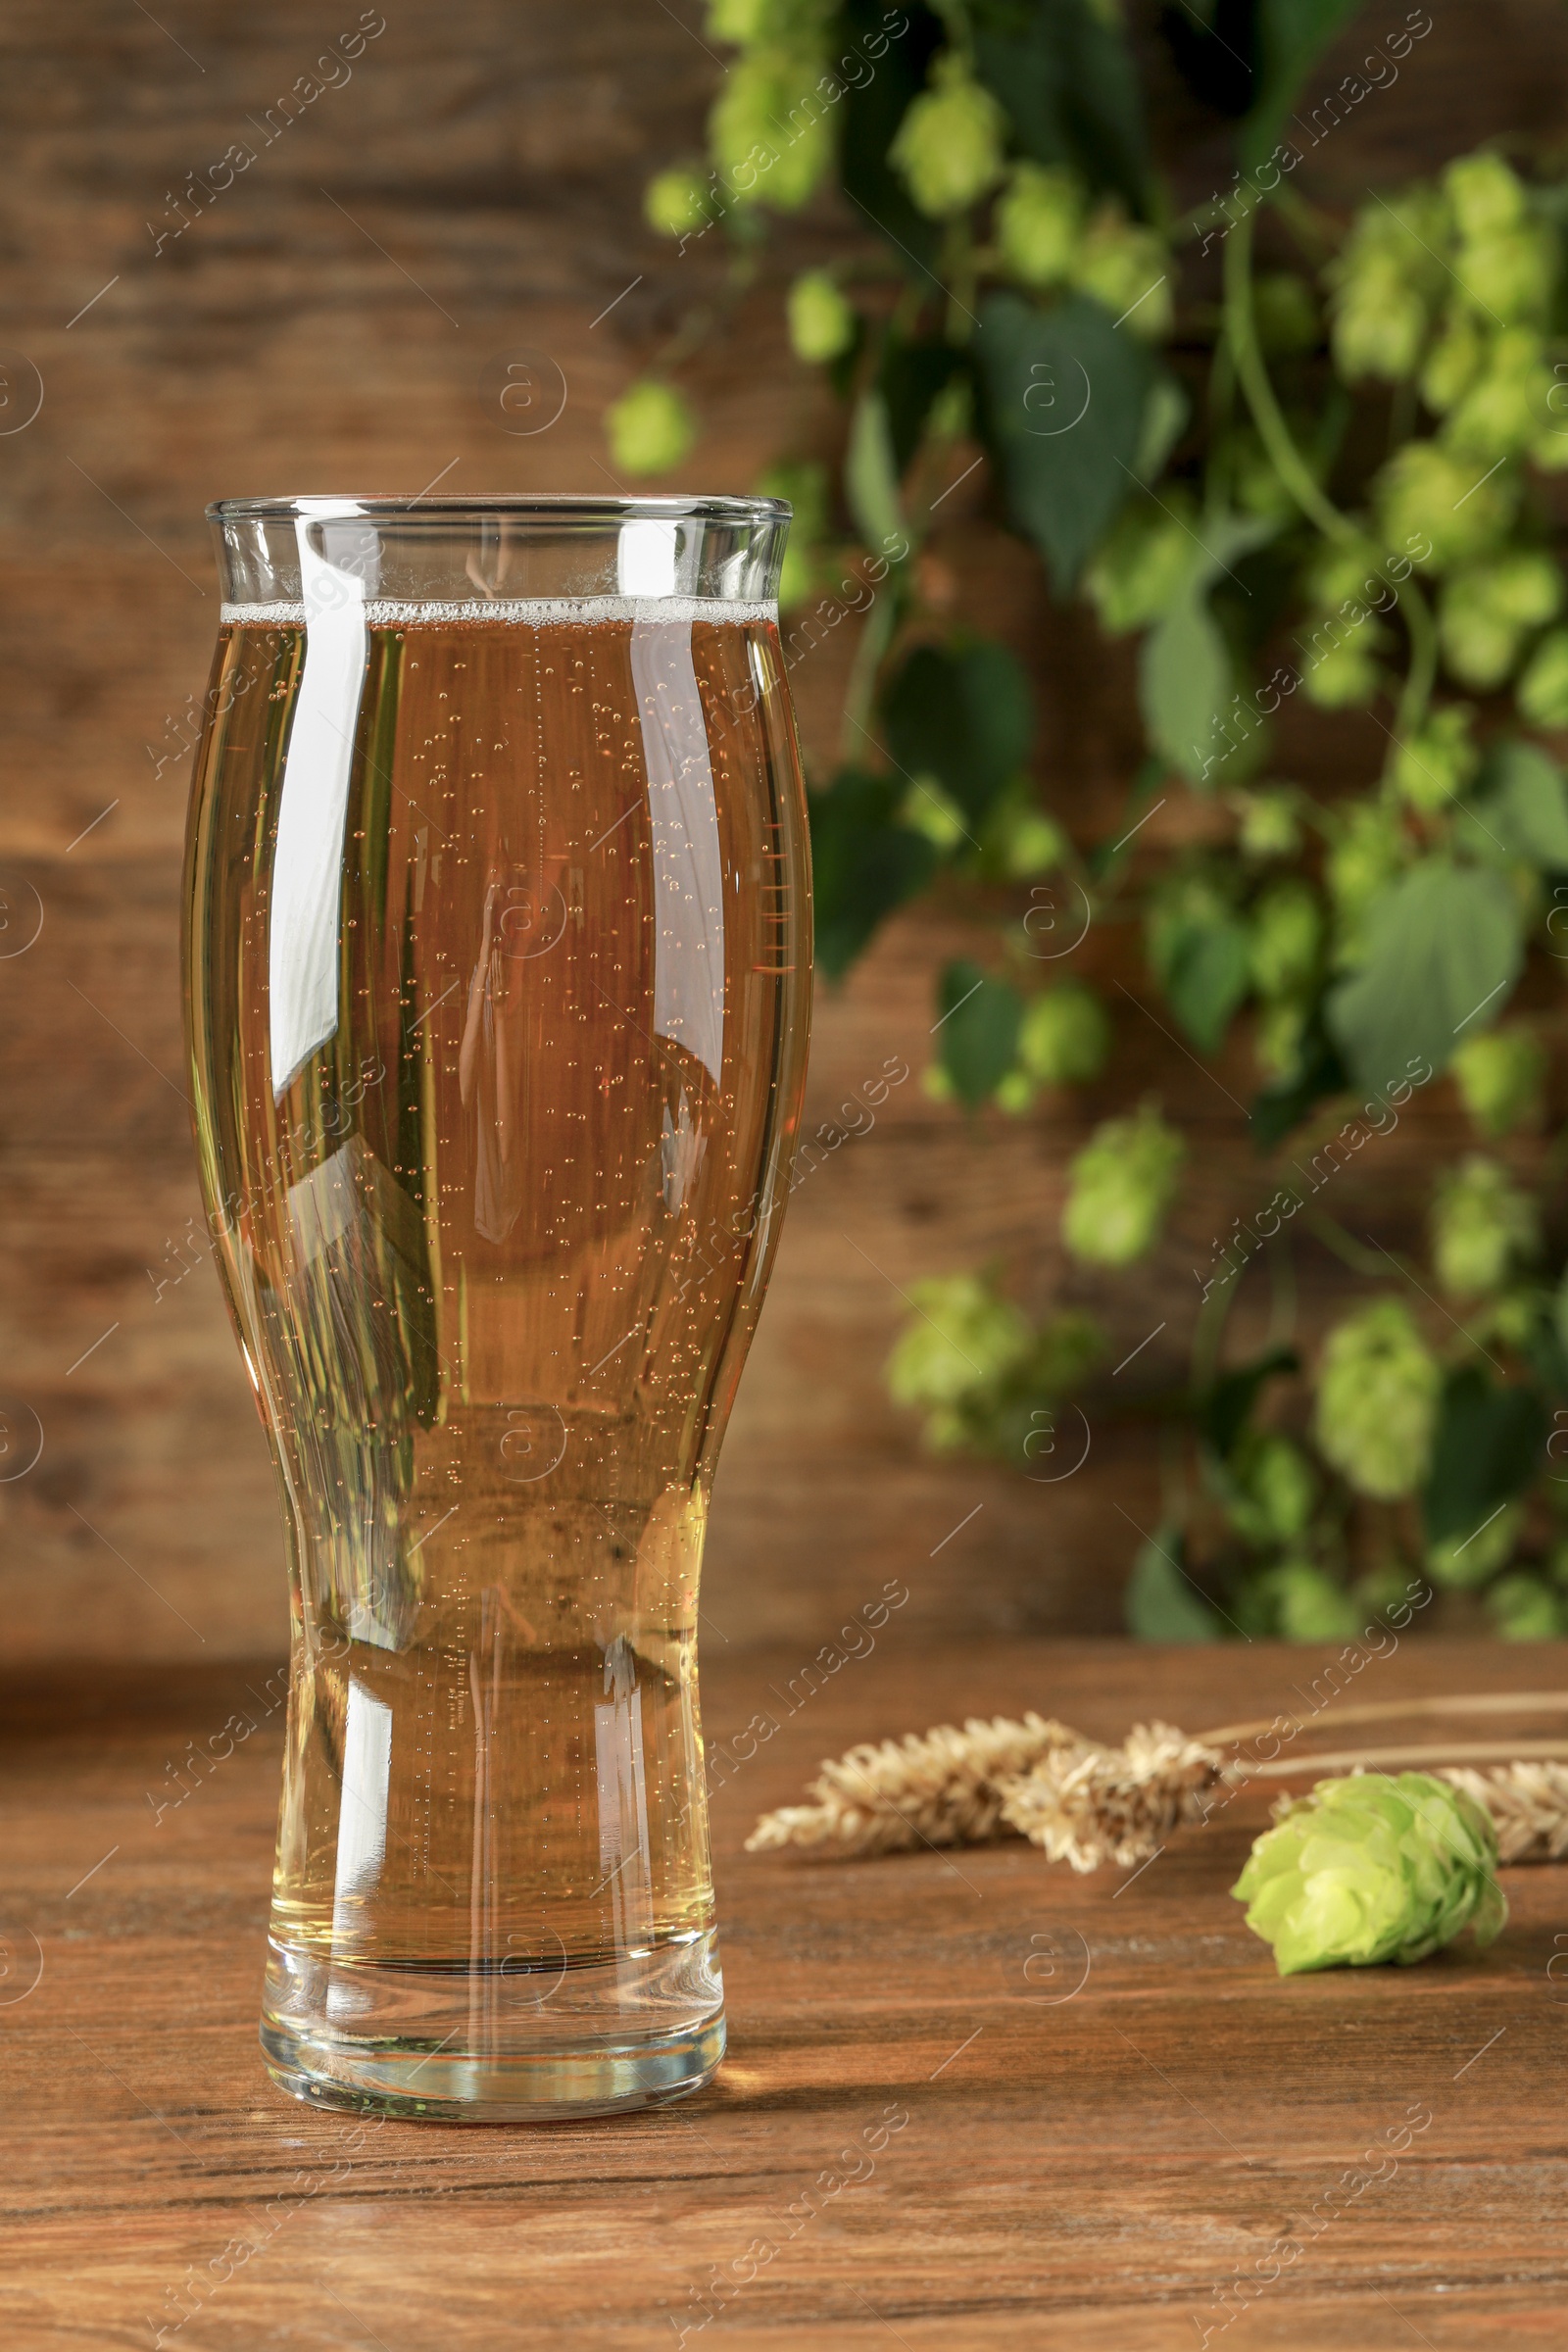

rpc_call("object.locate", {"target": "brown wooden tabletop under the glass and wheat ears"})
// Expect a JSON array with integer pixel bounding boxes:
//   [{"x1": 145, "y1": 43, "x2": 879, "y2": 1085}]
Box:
[{"x1": 0, "y1": 1628, "x2": 1568, "y2": 2352}]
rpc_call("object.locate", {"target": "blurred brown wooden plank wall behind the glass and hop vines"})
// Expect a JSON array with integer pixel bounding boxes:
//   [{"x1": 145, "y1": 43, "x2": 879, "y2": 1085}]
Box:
[{"x1": 0, "y1": 0, "x2": 1568, "y2": 1663}]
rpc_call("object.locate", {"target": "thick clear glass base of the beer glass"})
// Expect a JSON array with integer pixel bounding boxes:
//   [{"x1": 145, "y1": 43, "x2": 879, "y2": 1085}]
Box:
[{"x1": 261, "y1": 1934, "x2": 724, "y2": 2124}]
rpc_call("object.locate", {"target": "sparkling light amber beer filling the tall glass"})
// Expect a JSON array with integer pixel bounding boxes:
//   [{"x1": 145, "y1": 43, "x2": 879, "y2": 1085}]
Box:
[{"x1": 188, "y1": 616, "x2": 808, "y2": 1989}]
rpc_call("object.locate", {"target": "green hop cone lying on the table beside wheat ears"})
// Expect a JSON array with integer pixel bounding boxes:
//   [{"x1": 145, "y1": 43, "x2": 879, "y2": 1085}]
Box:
[{"x1": 1232, "y1": 1771, "x2": 1507, "y2": 1976}]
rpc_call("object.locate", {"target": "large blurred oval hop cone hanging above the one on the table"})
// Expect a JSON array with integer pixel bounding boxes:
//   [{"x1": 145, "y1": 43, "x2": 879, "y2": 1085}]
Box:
[{"x1": 1312, "y1": 1298, "x2": 1444, "y2": 1503}]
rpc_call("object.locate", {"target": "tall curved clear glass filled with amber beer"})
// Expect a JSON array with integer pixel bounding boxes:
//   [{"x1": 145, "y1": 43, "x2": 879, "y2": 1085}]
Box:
[{"x1": 186, "y1": 499, "x2": 808, "y2": 2119}]
